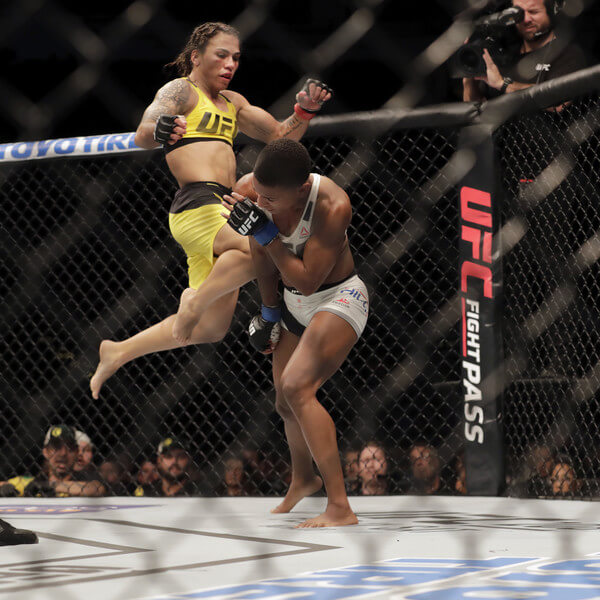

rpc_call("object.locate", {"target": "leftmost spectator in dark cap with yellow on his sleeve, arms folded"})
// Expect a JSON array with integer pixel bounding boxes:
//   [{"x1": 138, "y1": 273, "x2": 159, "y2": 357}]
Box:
[{"x1": 2, "y1": 424, "x2": 106, "y2": 497}]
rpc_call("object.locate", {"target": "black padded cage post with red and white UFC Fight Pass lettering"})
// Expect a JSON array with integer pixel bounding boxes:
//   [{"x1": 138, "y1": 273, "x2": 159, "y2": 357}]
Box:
[{"x1": 459, "y1": 126, "x2": 504, "y2": 496}]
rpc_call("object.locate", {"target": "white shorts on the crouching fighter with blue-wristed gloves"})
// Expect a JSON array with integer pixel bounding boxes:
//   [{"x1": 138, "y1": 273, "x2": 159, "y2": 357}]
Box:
[{"x1": 281, "y1": 275, "x2": 369, "y2": 337}]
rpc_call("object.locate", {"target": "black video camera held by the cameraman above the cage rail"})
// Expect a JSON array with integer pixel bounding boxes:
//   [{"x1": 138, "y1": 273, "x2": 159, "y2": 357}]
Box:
[{"x1": 450, "y1": 6, "x2": 525, "y2": 77}]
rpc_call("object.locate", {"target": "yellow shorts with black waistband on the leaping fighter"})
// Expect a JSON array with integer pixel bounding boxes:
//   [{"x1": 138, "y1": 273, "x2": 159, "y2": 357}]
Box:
[{"x1": 169, "y1": 182, "x2": 230, "y2": 289}]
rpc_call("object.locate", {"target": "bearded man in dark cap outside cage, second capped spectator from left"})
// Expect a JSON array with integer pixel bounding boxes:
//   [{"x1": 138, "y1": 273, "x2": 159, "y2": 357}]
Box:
[{"x1": 134, "y1": 437, "x2": 197, "y2": 496}]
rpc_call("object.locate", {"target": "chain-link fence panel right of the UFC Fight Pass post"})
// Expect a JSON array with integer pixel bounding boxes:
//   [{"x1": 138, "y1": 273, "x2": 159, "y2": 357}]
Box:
[{"x1": 496, "y1": 95, "x2": 600, "y2": 496}]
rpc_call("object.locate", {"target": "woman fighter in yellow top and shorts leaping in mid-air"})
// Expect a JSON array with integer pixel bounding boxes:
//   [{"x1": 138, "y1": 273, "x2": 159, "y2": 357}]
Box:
[{"x1": 90, "y1": 23, "x2": 331, "y2": 398}]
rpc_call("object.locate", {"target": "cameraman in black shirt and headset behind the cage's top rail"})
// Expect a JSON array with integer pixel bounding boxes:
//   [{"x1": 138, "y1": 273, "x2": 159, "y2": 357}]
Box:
[{"x1": 463, "y1": 0, "x2": 585, "y2": 103}]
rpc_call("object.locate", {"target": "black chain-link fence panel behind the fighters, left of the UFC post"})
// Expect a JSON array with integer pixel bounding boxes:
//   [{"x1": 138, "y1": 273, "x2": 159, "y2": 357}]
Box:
[{"x1": 0, "y1": 116, "x2": 460, "y2": 495}]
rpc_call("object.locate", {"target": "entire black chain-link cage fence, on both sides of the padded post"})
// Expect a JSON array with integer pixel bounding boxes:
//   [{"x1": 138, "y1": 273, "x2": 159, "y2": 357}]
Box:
[{"x1": 0, "y1": 81, "x2": 600, "y2": 497}]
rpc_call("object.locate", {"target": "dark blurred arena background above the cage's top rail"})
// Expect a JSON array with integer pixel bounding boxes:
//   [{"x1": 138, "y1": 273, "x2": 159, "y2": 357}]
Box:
[{"x1": 0, "y1": 0, "x2": 600, "y2": 142}]
